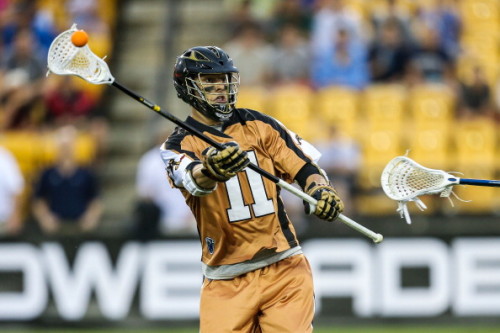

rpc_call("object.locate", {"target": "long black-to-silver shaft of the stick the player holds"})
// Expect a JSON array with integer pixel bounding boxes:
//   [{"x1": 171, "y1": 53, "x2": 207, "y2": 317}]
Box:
[{"x1": 111, "y1": 81, "x2": 383, "y2": 243}]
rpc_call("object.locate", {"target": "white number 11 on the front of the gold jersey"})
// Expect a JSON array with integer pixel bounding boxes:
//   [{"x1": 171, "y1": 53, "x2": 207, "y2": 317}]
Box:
[{"x1": 226, "y1": 151, "x2": 274, "y2": 222}]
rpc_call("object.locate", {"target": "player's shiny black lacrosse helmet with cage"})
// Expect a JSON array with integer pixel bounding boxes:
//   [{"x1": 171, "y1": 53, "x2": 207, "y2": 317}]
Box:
[{"x1": 174, "y1": 46, "x2": 240, "y2": 121}]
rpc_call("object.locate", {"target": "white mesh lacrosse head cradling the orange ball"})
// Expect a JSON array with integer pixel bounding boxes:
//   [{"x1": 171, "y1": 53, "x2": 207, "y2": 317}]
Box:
[{"x1": 47, "y1": 24, "x2": 115, "y2": 84}]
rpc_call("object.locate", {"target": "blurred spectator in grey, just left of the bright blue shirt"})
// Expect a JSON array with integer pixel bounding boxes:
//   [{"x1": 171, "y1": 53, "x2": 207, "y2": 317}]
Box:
[{"x1": 271, "y1": 24, "x2": 311, "y2": 85}]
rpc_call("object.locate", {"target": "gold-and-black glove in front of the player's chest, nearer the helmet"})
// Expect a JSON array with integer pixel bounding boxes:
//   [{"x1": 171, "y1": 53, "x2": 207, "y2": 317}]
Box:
[{"x1": 201, "y1": 141, "x2": 250, "y2": 182}]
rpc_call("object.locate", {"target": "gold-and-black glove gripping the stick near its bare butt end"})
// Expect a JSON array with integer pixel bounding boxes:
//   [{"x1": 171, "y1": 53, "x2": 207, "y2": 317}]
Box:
[{"x1": 305, "y1": 183, "x2": 344, "y2": 221}]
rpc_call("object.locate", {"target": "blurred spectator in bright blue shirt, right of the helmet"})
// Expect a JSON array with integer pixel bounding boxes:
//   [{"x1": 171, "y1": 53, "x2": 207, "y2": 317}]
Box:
[{"x1": 311, "y1": 29, "x2": 369, "y2": 90}]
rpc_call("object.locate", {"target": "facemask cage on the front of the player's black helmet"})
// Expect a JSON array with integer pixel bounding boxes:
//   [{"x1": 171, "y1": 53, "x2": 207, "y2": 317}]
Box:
[{"x1": 185, "y1": 72, "x2": 240, "y2": 121}]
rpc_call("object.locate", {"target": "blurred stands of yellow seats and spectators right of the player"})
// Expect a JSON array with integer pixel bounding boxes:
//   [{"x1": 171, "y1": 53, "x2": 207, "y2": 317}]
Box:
[{"x1": 222, "y1": 0, "x2": 500, "y2": 227}]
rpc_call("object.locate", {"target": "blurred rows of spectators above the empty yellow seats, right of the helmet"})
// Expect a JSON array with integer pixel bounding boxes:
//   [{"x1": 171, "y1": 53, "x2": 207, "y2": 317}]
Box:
[{"x1": 223, "y1": 0, "x2": 500, "y2": 116}]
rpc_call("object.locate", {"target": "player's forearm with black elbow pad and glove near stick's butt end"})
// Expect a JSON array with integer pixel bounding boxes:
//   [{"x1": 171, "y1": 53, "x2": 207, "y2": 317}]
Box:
[{"x1": 295, "y1": 163, "x2": 344, "y2": 221}]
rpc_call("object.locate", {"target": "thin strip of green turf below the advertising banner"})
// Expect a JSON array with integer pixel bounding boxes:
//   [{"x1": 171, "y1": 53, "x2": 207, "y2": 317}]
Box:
[{"x1": 1, "y1": 323, "x2": 500, "y2": 333}]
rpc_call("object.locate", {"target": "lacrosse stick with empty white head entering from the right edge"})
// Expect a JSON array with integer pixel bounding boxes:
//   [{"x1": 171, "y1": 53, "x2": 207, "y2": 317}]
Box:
[{"x1": 381, "y1": 156, "x2": 500, "y2": 224}]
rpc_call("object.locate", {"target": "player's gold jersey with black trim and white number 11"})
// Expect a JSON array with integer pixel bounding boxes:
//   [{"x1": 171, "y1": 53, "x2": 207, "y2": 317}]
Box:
[{"x1": 162, "y1": 109, "x2": 319, "y2": 266}]
